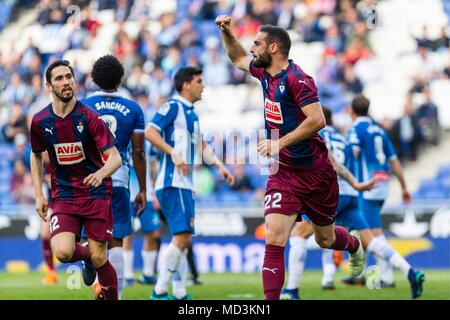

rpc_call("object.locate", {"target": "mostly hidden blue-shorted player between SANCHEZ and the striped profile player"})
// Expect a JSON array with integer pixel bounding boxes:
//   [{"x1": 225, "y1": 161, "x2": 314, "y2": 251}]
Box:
[{"x1": 123, "y1": 148, "x2": 161, "y2": 285}]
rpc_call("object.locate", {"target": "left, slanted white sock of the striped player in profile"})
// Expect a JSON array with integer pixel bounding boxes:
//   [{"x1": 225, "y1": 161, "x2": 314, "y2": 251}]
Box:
[{"x1": 154, "y1": 242, "x2": 183, "y2": 294}]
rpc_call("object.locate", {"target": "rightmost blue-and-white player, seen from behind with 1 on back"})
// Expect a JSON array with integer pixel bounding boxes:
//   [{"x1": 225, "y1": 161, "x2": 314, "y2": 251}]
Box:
[{"x1": 349, "y1": 95, "x2": 425, "y2": 298}]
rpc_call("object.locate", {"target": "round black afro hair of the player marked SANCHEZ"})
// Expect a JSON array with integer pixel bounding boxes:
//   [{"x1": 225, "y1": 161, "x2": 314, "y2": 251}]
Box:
[{"x1": 91, "y1": 54, "x2": 124, "y2": 90}]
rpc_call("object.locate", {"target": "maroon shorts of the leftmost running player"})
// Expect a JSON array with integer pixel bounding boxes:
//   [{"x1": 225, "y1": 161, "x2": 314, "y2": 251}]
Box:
[{"x1": 50, "y1": 198, "x2": 113, "y2": 241}]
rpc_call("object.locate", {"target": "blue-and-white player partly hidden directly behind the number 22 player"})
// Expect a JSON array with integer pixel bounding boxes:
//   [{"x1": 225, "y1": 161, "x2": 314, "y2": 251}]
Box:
[{"x1": 282, "y1": 108, "x2": 426, "y2": 300}]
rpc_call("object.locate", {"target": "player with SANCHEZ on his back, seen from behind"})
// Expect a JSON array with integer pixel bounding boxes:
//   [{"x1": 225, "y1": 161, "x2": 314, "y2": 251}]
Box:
[{"x1": 83, "y1": 55, "x2": 147, "y2": 299}]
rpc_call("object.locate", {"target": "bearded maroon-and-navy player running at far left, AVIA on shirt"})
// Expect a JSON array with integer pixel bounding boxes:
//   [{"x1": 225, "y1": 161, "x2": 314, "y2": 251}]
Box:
[{"x1": 30, "y1": 60, "x2": 122, "y2": 300}]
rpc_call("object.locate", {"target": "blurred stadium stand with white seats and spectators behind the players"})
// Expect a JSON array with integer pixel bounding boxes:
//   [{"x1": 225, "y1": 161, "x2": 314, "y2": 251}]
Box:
[{"x1": 0, "y1": 0, "x2": 450, "y2": 207}]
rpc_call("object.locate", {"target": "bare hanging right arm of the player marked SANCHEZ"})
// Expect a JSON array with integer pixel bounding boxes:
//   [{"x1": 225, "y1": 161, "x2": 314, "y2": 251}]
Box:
[{"x1": 131, "y1": 132, "x2": 147, "y2": 217}]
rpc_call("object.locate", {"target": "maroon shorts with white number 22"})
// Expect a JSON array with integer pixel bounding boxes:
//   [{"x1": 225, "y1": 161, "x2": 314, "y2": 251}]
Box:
[{"x1": 264, "y1": 159, "x2": 339, "y2": 226}]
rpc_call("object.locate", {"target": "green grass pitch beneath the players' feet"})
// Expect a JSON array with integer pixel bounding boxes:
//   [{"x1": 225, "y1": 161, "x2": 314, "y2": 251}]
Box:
[{"x1": 0, "y1": 269, "x2": 450, "y2": 300}]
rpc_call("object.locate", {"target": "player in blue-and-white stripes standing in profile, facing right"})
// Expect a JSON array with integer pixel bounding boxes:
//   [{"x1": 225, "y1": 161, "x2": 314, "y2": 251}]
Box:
[{"x1": 145, "y1": 67, "x2": 234, "y2": 300}]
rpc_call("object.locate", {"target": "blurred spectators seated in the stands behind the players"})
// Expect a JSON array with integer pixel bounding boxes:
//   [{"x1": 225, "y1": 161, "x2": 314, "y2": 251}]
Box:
[{"x1": 0, "y1": 0, "x2": 450, "y2": 205}]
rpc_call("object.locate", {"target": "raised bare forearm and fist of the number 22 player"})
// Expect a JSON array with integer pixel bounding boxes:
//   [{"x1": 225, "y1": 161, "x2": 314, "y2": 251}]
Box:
[{"x1": 216, "y1": 15, "x2": 250, "y2": 72}]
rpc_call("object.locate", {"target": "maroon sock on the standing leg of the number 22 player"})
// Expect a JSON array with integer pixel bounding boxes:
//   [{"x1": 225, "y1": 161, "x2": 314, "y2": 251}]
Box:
[{"x1": 262, "y1": 244, "x2": 284, "y2": 300}]
